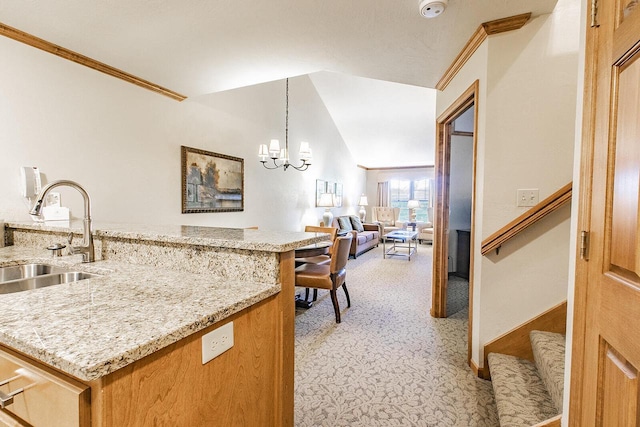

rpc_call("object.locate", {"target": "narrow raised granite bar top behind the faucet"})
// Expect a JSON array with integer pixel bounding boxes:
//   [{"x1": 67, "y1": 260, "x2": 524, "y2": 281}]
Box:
[{"x1": 5, "y1": 220, "x2": 326, "y2": 252}]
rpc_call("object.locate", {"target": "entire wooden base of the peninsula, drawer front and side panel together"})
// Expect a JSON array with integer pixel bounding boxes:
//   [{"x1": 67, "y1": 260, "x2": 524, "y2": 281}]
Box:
[{"x1": 0, "y1": 251, "x2": 295, "y2": 427}]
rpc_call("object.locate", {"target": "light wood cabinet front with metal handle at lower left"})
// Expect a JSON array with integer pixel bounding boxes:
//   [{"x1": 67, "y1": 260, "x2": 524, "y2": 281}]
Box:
[{"x1": 0, "y1": 350, "x2": 91, "y2": 427}]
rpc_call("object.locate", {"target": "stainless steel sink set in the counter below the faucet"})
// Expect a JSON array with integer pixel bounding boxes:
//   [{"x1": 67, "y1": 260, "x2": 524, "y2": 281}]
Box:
[{"x1": 0, "y1": 264, "x2": 97, "y2": 294}]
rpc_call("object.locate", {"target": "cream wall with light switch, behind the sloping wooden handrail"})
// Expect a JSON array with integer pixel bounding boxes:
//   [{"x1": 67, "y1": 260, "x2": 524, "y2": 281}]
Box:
[{"x1": 437, "y1": 0, "x2": 579, "y2": 366}]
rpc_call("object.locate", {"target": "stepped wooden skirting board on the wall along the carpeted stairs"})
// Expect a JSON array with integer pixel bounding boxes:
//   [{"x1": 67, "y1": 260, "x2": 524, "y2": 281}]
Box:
[{"x1": 481, "y1": 301, "x2": 567, "y2": 380}]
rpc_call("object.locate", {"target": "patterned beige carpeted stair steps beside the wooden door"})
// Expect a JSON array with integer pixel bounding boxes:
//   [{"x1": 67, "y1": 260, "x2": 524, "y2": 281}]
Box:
[{"x1": 488, "y1": 331, "x2": 566, "y2": 427}]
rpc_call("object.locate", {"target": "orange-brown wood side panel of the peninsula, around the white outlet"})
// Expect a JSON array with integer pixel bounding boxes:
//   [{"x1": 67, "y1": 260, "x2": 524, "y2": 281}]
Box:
[{"x1": 91, "y1": 251, "x2": 295, "y2": 427}]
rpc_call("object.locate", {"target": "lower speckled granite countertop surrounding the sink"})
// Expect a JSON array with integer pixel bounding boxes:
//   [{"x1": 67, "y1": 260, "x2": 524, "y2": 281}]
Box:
[{"x1": 0, "y1": 246, "x2": 278, "y2": 381}]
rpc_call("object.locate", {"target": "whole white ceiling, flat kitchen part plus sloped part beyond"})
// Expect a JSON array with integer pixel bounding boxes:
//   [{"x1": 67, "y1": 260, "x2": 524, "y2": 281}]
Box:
[{"x1": 0, "y1": 0, "x2": 557, "y2": 167}]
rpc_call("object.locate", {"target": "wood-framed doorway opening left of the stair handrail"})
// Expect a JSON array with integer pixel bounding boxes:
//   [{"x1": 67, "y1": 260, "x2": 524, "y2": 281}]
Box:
[{"x1": 431, "y1": 81, "x2": 479, "y2": 360}]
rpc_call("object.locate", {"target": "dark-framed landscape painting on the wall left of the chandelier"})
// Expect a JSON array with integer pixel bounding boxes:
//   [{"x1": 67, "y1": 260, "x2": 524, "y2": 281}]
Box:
[{"x1": 181, "y1": 146, "x2": 244, "y2": 213}]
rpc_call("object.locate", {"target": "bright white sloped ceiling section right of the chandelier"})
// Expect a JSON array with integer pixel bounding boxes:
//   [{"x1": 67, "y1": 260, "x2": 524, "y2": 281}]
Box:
[{"x1": 311, "y1": 71, "x2": 436, "y2": 168}]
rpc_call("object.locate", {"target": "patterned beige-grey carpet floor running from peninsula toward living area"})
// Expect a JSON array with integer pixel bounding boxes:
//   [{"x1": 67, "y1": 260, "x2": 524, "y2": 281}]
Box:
[{"x1": 295, "y1": 245, "x2": 498, "y2": 427}]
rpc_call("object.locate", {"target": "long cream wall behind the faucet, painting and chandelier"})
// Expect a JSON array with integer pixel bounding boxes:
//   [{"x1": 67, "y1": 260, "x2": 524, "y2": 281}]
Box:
[{"x1": 0, "y1": 37, "x2": 365, "y2": 230}]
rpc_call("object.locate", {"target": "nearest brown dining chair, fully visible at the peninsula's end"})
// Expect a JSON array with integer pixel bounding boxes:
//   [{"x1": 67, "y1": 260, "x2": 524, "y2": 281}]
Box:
[{"x1": 295, "y1": 234, "x2": 352, "y2": 323}]
